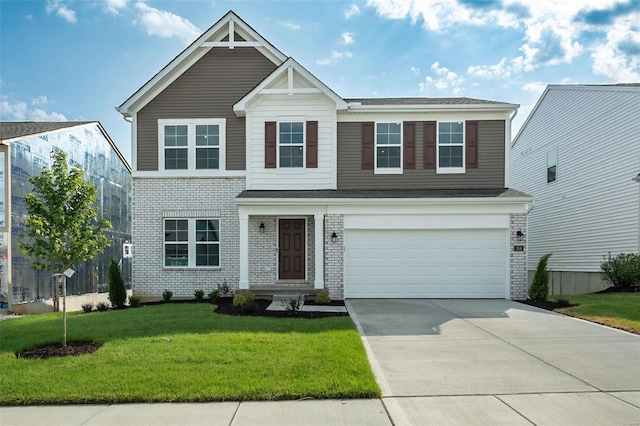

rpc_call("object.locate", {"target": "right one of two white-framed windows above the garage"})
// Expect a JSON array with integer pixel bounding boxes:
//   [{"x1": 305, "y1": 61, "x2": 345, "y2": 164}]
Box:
[{"x1": 437, "y1": 121, "x2": 465, "y2": 173}]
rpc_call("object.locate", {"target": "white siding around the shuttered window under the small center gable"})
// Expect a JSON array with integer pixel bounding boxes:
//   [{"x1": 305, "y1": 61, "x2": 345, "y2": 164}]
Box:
[{"x1": 246, "y1": 94, "x2": 336, "y2": 190}]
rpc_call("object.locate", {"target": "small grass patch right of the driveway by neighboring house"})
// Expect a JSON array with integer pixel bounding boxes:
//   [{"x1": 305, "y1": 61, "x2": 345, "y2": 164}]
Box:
[{"x1": 551, "y1": 293, "x2": 640, "y2": 334}]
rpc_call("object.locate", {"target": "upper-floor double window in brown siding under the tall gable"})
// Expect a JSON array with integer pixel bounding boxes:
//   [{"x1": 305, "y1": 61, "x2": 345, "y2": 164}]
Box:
[{"x1": 158, "y1": 118, "x2": 226, "y2": 171}]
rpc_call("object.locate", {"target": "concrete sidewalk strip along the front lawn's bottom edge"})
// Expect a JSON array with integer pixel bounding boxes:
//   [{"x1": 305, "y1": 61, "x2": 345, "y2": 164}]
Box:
[{"x1": 0, "y1": 399, "x2": 392, "y2": 426}]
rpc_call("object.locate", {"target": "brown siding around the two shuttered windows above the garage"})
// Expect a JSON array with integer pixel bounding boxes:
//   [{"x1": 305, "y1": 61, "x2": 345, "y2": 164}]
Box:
[{"x1": 338, "y1": 120, "x2": 505, "y2": 189}]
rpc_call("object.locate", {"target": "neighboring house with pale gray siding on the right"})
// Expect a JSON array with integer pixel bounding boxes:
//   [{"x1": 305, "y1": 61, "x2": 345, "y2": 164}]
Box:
[{"x1": 511, "y1": 84, "x2": 640, "y2": 294}]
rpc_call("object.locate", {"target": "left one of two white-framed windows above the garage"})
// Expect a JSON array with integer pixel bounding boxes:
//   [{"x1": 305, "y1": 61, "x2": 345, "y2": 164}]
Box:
[{"x1": 374, "y1": 122, "x2": 402, "y2": 174}]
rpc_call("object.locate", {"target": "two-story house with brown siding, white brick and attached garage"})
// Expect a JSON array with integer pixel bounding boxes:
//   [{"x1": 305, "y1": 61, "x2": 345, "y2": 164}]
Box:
[{"x1": 118, "y1": 12, "x2": 532, "y2": 299}]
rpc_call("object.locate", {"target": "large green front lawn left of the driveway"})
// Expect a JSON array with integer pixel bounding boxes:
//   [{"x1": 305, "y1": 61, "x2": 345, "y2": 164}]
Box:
[{"x1": 0, "y1": 304, "x2": 380, "y2": 405}]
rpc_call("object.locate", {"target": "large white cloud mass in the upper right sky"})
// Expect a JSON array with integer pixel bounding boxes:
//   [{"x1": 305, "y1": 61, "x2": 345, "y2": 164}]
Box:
[{"x1": 367, "y1": 0, "x2": 640, "y2": 78}]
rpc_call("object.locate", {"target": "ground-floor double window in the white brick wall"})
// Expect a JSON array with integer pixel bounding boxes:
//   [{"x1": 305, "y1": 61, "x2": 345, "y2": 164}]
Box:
[{"x1": 164, "y1": 218, "x2": 220, "y2": 268}]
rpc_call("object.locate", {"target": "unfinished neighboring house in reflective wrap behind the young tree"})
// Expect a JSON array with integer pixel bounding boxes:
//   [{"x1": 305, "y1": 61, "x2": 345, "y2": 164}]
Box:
[{"x1": 0, "y1": 121, "x2": 131, "y2": 312}]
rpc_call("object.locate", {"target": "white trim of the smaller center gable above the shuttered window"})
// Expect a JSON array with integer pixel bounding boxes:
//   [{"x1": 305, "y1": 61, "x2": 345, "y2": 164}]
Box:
[{"x1": 233, "y1": 57, "x2": 348, "y2": 117}]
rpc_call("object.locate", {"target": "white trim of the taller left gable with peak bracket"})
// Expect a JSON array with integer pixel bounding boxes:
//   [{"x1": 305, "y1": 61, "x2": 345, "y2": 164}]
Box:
[{"x1": 116, "y1": 10, "x2": 287, "y2": 117}]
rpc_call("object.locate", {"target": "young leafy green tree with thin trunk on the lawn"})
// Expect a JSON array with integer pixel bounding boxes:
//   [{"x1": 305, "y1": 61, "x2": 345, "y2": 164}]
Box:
[{"x1": 18, "y1": 150, "x2": 111, "y2": 349}]
